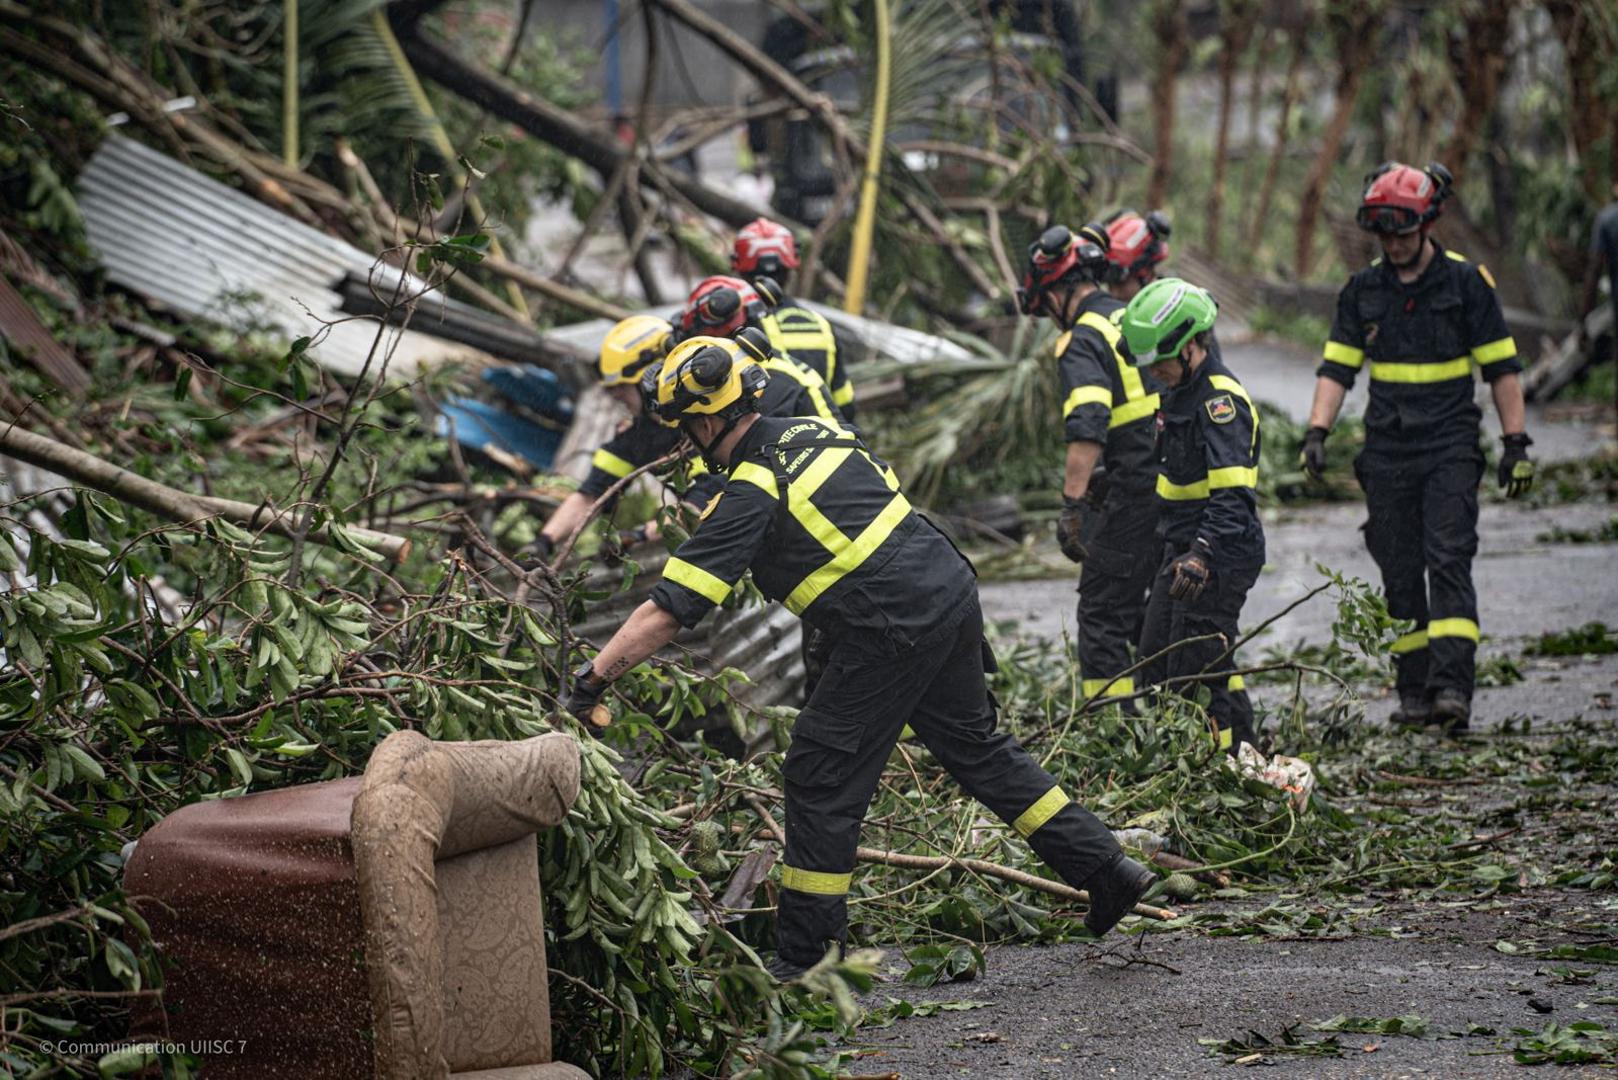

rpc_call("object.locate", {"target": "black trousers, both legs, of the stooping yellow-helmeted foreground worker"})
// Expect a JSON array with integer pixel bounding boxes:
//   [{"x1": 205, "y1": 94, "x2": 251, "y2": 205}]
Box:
[{"x1": 775, "y1": 589, "x2": 1121, "y2": 963}]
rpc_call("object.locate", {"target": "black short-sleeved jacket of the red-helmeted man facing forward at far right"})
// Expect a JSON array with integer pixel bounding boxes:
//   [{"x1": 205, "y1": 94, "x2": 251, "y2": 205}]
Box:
[{"x1": 1319, "y1": 241, "x2": 1523, "y2": 452}]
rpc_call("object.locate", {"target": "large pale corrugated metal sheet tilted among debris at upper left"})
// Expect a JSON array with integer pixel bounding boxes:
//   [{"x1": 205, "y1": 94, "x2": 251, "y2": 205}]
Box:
[{"x1": 79, "y1": 134, "x2": 489, "y2": 376}]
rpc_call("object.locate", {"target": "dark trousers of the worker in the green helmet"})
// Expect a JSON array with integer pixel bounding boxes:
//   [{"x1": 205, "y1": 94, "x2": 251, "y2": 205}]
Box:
[{"x1": 1141, "y1": 544, "x2": 1260, "y2": 748}]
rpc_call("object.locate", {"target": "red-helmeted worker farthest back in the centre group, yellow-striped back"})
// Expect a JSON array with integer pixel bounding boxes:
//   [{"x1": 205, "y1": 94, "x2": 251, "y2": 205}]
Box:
[{"x1": 730, "y1": 217, "x2": 856, "y2": 421}]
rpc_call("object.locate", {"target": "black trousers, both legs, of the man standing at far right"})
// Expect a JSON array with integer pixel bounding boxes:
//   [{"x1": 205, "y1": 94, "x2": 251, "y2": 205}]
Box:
[{"x1": 1354, "y1": 447, "x2": 1484, "y2": 698}]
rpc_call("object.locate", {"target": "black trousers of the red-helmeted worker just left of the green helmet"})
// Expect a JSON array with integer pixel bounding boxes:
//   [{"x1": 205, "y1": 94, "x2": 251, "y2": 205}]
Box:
[{"x1": 1079, "y1": 489, "x2": 1160, "y2": 698}]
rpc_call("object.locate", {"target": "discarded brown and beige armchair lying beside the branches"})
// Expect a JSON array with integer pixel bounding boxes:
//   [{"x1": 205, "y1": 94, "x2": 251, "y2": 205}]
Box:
[{"x1": 125, "y1": 732, "x2": 586, "y2": 1080}]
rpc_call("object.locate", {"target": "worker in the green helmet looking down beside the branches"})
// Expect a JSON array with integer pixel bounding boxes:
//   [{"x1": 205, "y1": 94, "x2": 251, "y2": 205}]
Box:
[{"x1": 1121, "y1": 277, "x2": 1264, "y2": 755}]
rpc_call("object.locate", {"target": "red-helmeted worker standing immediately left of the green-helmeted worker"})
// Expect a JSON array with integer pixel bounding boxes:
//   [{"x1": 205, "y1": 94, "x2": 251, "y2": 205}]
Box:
[{"x1": 1018, "y1": 225, "x2": 1158, "y2": 698}]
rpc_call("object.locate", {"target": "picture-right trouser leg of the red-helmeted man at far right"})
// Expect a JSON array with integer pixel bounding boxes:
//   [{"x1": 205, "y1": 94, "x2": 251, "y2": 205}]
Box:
[{"x1": 1422, "y1": 449, "x2": 1482, "y2": 696}]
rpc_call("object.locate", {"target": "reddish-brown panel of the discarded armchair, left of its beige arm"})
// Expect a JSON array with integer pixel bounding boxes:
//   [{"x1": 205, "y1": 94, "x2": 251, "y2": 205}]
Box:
[{"x1": 123, "y1": 777, "x2": 374, "y2": 1080}]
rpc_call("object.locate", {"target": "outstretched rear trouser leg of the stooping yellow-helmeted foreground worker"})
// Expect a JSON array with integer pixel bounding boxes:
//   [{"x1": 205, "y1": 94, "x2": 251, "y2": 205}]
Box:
[{"x1": 911, "y1": 602, "x2": 1118, "y2": 887}]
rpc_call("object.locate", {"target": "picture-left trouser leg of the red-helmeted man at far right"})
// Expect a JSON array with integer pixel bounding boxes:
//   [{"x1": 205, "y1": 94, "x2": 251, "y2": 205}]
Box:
[{"x1": 1356, "y1": 458, "x2": 1429, "y2": 695}]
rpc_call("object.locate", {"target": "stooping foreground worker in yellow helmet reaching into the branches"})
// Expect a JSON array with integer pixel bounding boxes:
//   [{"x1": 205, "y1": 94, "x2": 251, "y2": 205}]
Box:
[{"x1": 563, "y1": 337, "x2": 1154, "y2": 980}]
